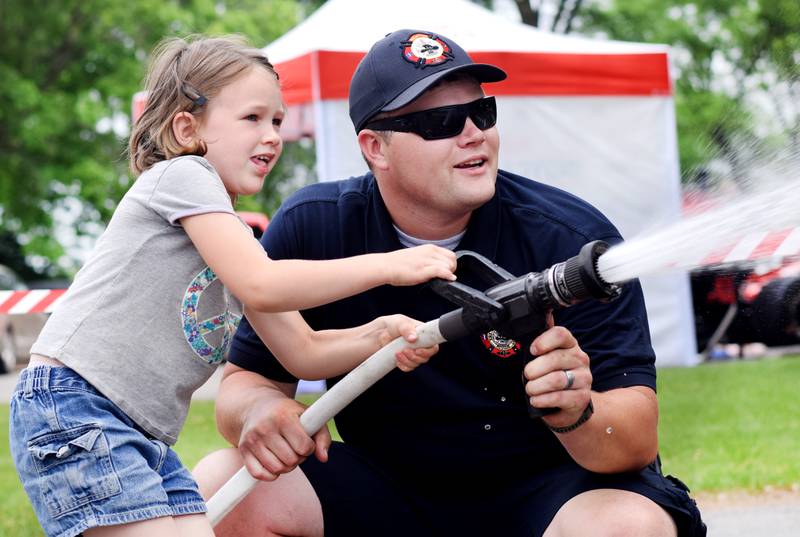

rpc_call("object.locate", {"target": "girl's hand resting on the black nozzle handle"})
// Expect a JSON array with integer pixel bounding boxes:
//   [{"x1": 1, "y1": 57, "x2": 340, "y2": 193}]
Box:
[{"x1": 381, "y1": 244, "x2": 456, "y2": 285}]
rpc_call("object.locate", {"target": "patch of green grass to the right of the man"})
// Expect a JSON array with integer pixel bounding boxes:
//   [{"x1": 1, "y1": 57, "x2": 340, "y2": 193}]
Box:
[{"x1": 658, "y1": 357, "x2": 800, "y2": 491}]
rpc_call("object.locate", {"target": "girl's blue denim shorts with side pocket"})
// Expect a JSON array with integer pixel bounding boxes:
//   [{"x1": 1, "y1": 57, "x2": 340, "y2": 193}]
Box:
[{"x1": 9, "y1": 366, "x2": 206, "y2": 537}]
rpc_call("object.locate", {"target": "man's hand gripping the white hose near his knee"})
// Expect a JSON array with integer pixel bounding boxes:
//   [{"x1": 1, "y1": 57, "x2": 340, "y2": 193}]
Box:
[{"x1": 239, "y1": 398, "x2": 331, "y2": 481}]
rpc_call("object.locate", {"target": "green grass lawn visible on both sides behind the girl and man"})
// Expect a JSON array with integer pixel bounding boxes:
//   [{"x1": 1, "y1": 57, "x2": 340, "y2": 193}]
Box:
[{"x1": 0, "y1": 357, "x2": 800, "y2": 537}]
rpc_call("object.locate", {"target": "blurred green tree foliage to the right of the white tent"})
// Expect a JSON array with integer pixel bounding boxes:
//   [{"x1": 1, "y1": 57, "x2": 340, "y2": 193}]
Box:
[{"x1": 506, "y1": 0, "x2": 800, "y2": 181}]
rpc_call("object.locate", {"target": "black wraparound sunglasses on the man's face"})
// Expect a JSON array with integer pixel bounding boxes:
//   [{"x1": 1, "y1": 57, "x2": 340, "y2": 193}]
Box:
[{"x1": 363, "y1": 97, "x2": 497, "y2": 140}]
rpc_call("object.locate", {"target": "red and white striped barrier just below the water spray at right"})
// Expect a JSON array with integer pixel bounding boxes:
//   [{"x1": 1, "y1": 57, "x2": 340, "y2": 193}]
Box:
[{"x1": 699, "y1": 228, "x2": 800, "y2": 266}]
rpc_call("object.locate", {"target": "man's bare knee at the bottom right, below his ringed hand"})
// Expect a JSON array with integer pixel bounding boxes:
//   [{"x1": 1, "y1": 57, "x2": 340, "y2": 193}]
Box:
[{"x1": 544, "y1": 489, "x2": 678, "y2": 537}]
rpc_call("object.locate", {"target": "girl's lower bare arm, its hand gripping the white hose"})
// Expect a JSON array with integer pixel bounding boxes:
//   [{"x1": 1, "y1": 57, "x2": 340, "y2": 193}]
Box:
[{"x1": 244, "y1": 307, "x2": 439, "y2": 380}]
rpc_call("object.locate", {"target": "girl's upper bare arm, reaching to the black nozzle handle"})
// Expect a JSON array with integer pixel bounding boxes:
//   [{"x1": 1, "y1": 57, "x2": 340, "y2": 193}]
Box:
[{"x1": 181, "y1": 213, "x2": 456, "y2": 312}]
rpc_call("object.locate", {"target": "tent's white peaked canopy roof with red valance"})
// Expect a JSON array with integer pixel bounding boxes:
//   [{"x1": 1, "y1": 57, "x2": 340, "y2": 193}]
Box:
[{"x1": 272, "y1": 0, "x2": 670, "y2": 104}]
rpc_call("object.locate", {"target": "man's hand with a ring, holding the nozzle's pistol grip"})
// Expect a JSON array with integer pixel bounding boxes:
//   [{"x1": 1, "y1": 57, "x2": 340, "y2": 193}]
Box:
[{"x1": 524, "y1": 322, "x2": 592, "y2": 427}]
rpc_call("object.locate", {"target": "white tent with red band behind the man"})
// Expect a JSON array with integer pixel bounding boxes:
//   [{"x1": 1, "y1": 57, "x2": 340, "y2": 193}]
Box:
[{"x1": 265, "y1": 0, "x2": 696, "y2": 366}]
